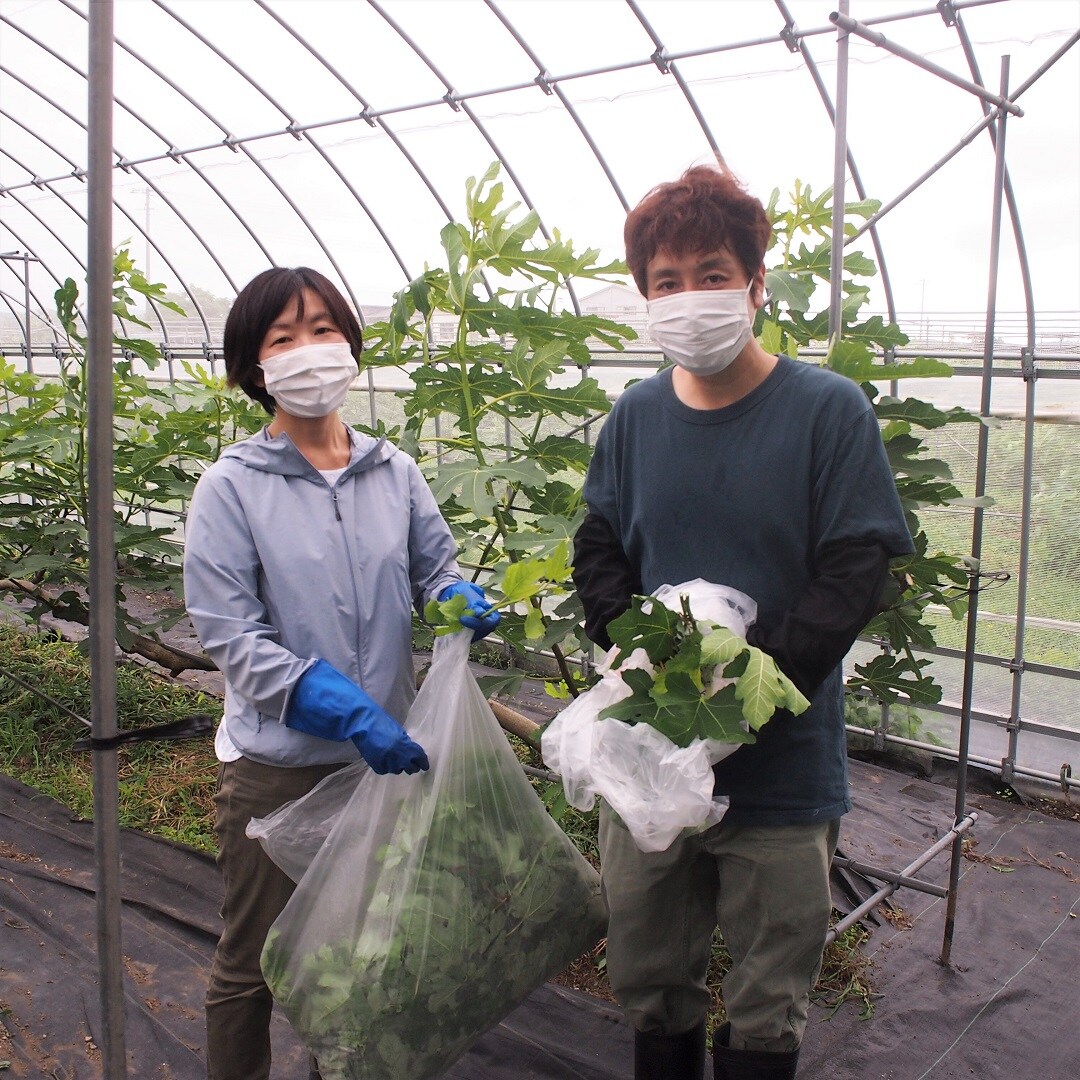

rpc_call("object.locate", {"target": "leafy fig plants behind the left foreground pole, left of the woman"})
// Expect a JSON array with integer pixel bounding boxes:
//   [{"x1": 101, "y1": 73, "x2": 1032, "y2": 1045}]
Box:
[{"x1": 0, "y1": 248, "x2": 264, "y2": 671}]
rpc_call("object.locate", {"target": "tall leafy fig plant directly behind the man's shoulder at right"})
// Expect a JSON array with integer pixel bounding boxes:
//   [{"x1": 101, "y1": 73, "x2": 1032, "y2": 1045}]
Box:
[{"x1": 755, "y1": 183, "x2": 989, "y2": 704}]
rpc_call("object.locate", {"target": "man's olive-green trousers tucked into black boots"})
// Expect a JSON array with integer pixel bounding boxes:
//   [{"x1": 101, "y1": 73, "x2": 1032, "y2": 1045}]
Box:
[{"x1": 599, "y1": 806, "x2": 839, "y2": 1052}]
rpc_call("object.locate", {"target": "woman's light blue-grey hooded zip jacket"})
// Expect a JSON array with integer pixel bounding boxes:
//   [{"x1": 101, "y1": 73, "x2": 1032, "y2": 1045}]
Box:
[{"x1": 184, "y1": 429, "x2": 461, "y2": 766}]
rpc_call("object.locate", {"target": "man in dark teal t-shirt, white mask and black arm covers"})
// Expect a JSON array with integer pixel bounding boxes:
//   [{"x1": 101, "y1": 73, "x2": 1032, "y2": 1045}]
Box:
[{"x1": 573, "y1": 166, "x2": 913, "y2": 1080}]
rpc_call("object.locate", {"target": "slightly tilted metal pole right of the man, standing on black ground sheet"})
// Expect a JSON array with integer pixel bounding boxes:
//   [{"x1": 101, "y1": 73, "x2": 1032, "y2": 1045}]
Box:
[{"x1": 941, "y1": 56, "x2": 1009, "y2": 966}]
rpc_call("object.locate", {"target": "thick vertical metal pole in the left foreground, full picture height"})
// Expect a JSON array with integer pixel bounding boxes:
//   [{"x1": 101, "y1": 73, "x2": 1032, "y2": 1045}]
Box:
[{"x1": 86, "y1": 0, "x2": 127, "y2": 1080}]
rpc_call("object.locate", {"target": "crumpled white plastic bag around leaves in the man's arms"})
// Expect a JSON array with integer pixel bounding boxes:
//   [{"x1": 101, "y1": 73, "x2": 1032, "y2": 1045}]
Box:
[{"x1": 541, "y1": 578, "x2": 757, "y2": 851}]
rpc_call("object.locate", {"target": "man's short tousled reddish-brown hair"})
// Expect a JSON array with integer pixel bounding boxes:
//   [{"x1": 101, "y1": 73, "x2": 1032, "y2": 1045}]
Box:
[{"x1": 623, "y1": 165, "x2": 772, "y2": 296}]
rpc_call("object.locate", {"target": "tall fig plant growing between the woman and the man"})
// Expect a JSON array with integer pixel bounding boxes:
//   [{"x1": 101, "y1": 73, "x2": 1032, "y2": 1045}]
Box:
[{"x1": 365, "y1": 164, "x2": 636, "y2": 693}]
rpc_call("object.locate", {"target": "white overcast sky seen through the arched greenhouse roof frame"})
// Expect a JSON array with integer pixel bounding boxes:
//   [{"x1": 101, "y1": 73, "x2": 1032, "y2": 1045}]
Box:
[{"x1": 0, "y1": 0, "x2": 1080, "y2": 314}]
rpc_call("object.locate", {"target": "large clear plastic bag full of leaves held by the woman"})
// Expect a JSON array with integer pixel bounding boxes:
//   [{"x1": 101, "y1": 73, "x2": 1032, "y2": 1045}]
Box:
[{"x1": 253, "y1": 633, "x2": 607, "y2": 1080}]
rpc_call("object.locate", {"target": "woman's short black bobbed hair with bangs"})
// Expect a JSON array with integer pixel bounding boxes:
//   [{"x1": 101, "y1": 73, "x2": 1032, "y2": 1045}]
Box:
[{"x1": 224, "y1": 267, "x2": 364, "y2": 416}]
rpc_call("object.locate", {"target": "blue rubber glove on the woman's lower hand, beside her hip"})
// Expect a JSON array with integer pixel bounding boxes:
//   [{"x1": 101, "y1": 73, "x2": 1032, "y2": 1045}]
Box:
[{"x1": 285, "y1": 660, "x2": 428, "y2": 773}]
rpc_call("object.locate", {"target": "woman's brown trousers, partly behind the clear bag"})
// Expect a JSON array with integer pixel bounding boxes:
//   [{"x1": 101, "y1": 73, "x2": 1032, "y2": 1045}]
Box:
[{"x1": 206, "y1": 757, "x2": 341, "y2": 1080}]
